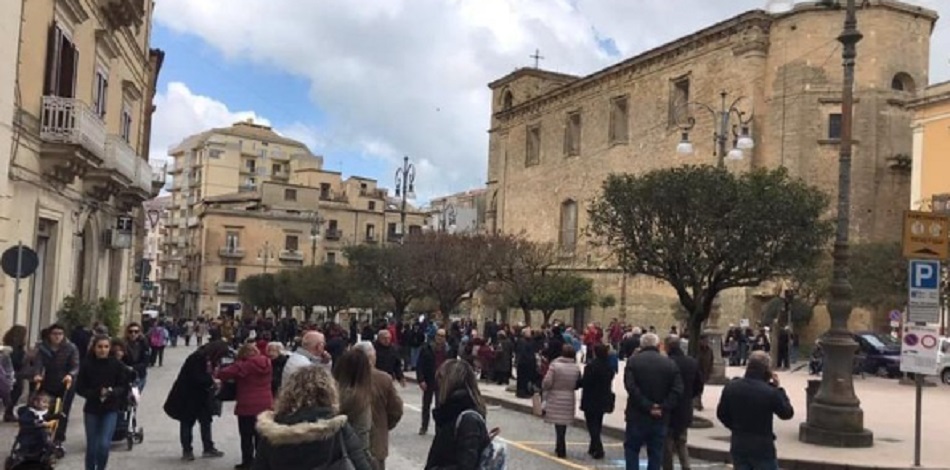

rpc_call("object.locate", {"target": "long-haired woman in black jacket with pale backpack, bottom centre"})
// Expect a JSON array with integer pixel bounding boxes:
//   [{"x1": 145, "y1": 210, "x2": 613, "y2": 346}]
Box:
[{"x1": 425, "y1": 359, "x2": 494, "y2": 470}]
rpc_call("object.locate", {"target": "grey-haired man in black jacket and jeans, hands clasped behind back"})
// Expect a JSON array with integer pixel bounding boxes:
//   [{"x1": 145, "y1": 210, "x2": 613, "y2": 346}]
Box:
[{"x1": 623, "y1": 333, "x2": 683, "y2": 470}]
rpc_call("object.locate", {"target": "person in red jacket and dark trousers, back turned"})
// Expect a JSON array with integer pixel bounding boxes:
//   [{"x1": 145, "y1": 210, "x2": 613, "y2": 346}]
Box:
[{"x1": 217, "y1": 343, "x2": 274, "y2": 470}]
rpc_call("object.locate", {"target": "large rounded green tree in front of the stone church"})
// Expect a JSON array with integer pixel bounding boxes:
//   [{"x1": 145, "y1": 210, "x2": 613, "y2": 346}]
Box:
[{"x1": 589, "y1": 165, "x2": 832, "y2": 349}]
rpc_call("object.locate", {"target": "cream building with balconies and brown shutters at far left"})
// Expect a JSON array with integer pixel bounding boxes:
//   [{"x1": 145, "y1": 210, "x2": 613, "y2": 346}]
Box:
[{"x1": 0, "y1": 0, "x2": 164, "y2": 338}]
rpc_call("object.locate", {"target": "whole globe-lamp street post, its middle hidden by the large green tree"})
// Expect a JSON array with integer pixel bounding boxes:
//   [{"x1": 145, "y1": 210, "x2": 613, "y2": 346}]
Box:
[{"x1": 676, "y1": 91, "x2": 755, "y2": 385}]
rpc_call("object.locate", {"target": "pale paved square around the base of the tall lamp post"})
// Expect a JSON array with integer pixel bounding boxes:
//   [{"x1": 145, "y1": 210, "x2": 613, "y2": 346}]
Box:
[{"x1": 430, "y1": 363, "x2": 950, "y2": 470}]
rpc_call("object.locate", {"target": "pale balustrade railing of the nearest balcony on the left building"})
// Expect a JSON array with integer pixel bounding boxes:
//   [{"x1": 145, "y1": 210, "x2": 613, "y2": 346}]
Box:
[{"x1": 40, "y1": 96, "x2": 106, "y2": 159}]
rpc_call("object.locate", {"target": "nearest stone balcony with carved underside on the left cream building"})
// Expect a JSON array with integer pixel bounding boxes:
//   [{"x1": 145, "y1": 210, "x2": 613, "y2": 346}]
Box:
[{"x1": 40, "y1": 96, "x2": 106, "y2": 185}]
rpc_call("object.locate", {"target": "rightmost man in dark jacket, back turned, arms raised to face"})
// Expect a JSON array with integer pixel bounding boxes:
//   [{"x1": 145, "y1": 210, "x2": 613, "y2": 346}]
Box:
[{"x1": 716, "y1": 351, "x2": 795, "y2": 470}]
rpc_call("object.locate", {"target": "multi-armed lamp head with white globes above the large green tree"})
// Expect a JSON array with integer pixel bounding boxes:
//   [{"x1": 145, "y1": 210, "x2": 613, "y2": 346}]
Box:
[{"x1": 676, "y1": 91, "x2": 755, "y2": 168}]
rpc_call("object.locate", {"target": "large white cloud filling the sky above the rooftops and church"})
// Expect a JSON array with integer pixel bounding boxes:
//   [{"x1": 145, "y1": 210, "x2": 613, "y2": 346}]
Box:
[{"x1": 156, "y1": 0, "x2": 950, "y2": 199}]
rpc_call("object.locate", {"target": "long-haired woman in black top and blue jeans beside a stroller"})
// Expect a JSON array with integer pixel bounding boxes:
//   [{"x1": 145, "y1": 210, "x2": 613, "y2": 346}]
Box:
[{"x1": 76, "y1": 335, "x2": 129, "y2": 470}]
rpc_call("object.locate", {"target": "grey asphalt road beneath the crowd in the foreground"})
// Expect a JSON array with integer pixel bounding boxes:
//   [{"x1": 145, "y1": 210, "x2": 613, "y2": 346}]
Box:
[{"x1": 0, "y1": 346, "x2": 725, "y2": 470}]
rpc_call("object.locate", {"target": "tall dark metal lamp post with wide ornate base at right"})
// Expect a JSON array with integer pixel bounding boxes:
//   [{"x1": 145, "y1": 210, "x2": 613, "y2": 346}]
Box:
[{"x1": 798, "y1": 0, "x2": 874, "y2": 447}]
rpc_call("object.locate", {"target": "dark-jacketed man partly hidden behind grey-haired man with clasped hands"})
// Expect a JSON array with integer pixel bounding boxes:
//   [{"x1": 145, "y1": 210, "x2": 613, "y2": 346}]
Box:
[{"x1": 663, "y1": 335, "x2": 704, "y2": 470}]
